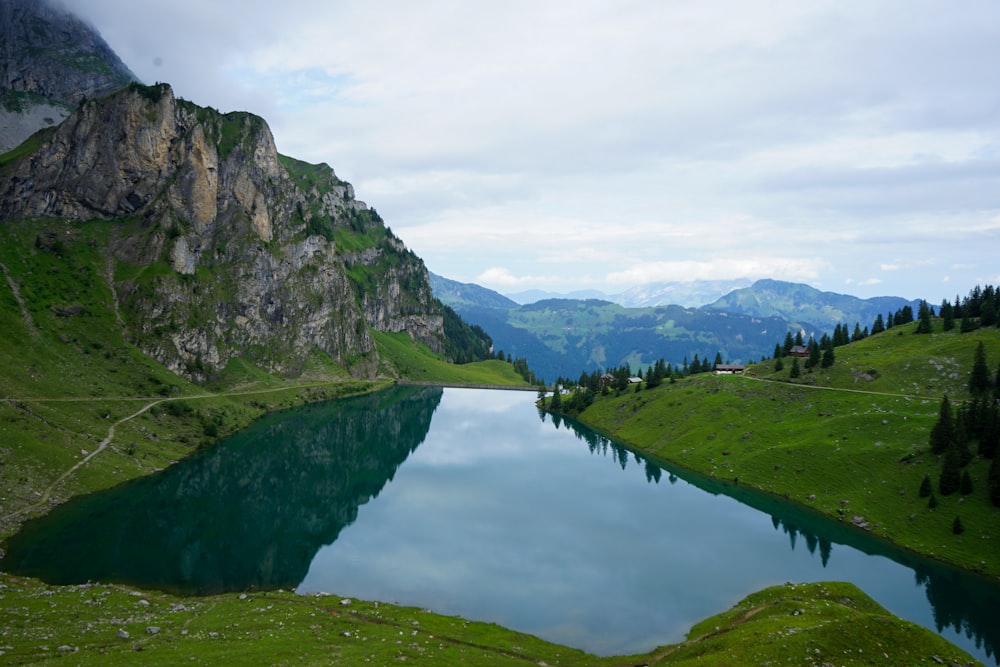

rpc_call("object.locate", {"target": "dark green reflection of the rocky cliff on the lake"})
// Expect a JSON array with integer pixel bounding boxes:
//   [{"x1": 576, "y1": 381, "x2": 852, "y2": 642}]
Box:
[{"x1": 2, "y1": 387, "x2": 443, "y2": 595}]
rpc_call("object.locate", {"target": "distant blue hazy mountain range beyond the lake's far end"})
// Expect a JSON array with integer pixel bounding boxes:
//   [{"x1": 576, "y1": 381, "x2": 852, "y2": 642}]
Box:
[{"x1": 431, "y1": 273, "x2": 919, "y2": 381}]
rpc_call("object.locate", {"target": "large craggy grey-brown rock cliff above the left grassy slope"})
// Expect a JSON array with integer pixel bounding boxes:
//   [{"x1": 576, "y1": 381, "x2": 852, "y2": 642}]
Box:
[{"x1": 0, "y1": 84, "x2": 445, "y2": 380}]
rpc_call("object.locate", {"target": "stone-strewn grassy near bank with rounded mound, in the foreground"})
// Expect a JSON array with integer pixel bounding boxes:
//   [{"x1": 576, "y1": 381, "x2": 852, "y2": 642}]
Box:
[{"x1": 0, "y1": 574, "x2": 976, "y2": 667}]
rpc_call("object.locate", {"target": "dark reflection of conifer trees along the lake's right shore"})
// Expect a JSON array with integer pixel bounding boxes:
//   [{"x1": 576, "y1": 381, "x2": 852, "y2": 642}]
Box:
[{"x1": 560, "y1": 416, "x2": 1000, "y2": 664}]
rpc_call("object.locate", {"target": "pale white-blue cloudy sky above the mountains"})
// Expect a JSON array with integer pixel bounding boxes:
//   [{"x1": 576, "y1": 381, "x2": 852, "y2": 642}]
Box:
[{"x1": 67, "y1": 0, "x2": 1000, "y2": 303}]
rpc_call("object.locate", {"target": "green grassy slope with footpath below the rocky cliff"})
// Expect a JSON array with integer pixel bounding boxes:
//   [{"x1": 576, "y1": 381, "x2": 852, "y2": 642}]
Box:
[{"x1": 0, "y1": 221, "x2": 524, "y2": 536}]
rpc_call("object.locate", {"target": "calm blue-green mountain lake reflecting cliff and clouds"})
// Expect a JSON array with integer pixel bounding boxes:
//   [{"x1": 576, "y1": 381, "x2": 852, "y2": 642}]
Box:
[{"x1": 0, "y1": 387, "x2": 1000, "y2": 663}]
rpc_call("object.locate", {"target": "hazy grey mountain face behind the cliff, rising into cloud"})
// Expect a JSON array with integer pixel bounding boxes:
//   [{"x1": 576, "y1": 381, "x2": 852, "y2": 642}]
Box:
[{"x1": 0, "y1": 0, "x2": 136, "y2": 153}]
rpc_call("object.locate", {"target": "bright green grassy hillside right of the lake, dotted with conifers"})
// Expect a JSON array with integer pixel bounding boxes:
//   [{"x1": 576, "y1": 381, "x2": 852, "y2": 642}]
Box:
[{"x1": 581, "y1": 323, "x2": 1000, "y2": 577}]
